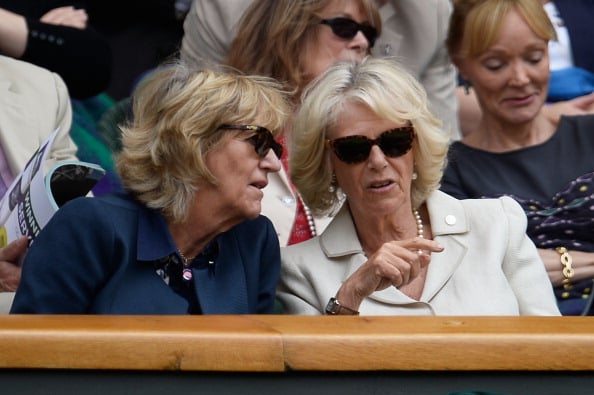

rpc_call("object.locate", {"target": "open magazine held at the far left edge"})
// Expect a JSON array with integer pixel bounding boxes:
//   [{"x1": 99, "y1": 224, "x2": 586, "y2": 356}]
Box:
[{"x1": 0, "y1": 132, "x2": 105, "y2": 247}]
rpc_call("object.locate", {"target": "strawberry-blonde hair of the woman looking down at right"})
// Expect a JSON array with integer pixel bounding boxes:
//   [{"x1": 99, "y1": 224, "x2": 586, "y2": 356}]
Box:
[{"x1": 446, "y1": 0, "x2": 556, "y2": 63}]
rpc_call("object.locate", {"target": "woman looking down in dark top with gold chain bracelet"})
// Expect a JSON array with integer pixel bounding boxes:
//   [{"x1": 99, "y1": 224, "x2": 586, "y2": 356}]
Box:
[{"x1": 442, "y1": 0, "x2": 594, "y2": 315}]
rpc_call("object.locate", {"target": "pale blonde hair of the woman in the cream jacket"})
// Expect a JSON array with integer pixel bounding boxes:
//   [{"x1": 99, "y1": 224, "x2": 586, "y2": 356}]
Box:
[{"x1": 289, "y1": 57, "x2": 449, "y2": 214}]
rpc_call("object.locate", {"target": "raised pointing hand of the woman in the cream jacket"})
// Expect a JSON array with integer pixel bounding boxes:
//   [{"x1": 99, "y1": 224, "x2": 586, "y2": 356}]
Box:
[{"x1": 336, "y1": 237, "x2": 443, "y2": 310}]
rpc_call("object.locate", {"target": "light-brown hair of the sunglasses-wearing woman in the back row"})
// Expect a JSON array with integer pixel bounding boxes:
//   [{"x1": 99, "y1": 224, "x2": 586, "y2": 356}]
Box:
[{"x1": 227, "y1": 0, "x2": 381, "y2": 94}]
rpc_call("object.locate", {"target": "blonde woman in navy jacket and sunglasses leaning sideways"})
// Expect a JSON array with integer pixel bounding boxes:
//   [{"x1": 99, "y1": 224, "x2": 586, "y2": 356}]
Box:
[{"x1": 11, "y1": 64, "x2": 287, "y2": 314}]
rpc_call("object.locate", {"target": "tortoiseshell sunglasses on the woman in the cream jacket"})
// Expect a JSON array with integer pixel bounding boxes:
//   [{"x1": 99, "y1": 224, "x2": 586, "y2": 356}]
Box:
[{"x1": 326, "y1": 126, "x2": 415, "y2": 163}]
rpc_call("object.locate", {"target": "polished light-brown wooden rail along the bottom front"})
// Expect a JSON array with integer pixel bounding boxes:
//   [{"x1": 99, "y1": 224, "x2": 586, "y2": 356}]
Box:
[{"x1": 0, "y1": 315, "x2": 594, "y2": 372}]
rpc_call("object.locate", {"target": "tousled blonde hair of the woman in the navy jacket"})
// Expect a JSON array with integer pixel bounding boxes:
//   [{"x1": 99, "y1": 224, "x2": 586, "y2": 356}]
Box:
[{"x1": 116, "y1": 62, "x2": 289, "y2": 222}]
